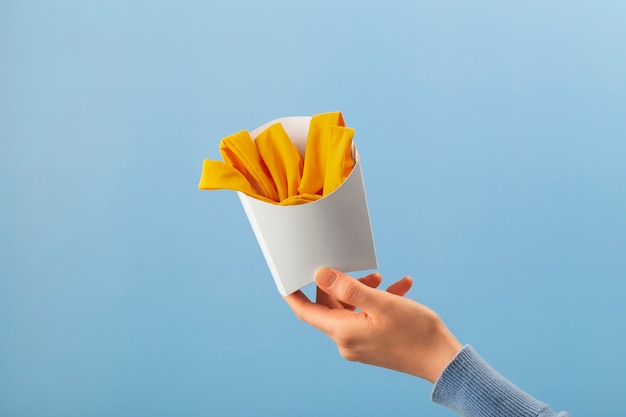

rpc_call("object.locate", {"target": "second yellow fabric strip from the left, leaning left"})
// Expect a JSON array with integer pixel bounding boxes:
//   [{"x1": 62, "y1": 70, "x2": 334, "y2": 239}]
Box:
[{"x1": 220, "y1": 130, "x2": 280, "y2": 202}]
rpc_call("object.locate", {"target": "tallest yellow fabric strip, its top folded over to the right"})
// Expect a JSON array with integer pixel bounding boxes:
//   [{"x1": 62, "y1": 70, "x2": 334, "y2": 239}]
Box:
[{"x1": 298, "y1": 112, "x2": 345, "y2": 195}]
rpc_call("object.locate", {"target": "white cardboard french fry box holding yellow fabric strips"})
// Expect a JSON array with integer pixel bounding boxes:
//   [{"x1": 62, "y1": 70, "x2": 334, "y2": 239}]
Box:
[{"x1": 238, "y1": 117, "x2": 378, "y2": 296}]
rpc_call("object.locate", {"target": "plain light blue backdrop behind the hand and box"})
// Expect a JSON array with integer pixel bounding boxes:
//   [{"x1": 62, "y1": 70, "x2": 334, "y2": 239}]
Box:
[{"x1": 0, "y1": 0, "x2": 626, "y2": 417}]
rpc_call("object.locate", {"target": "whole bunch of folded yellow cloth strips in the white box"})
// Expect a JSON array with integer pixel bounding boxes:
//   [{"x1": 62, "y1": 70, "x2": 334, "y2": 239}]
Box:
[{"x1": 198, "y1": 112, "x2": 354, "y2": 205}]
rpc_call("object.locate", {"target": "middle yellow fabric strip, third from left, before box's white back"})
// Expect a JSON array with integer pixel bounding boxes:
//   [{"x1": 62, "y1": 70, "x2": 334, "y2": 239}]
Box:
[{"x1": 254, "y1": 123, "x2": 303, "y2": 202}]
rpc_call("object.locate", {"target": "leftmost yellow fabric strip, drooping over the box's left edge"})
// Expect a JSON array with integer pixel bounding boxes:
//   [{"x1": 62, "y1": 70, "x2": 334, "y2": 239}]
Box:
[{"x1": 198, "y1": 159, "x2": 273, "y2": 203}]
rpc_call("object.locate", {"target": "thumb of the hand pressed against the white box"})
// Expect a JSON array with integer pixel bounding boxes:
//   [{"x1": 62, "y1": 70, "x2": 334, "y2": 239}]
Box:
[{"x1": 315, "y1": 268, "x2": 383, "y2": 309}]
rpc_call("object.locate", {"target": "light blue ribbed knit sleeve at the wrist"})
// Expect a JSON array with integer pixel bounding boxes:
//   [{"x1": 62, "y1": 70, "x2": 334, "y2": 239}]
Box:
[{"x1": 431, "y1": 345, "x2": 568, "y2": 417}]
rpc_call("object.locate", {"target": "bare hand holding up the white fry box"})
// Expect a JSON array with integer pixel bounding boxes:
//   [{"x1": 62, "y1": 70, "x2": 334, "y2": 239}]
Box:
[{"x1": 285, "y1": 269, "x2": 462, "y2": 383}]
